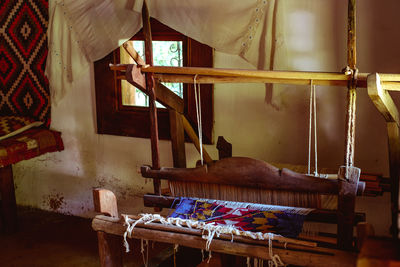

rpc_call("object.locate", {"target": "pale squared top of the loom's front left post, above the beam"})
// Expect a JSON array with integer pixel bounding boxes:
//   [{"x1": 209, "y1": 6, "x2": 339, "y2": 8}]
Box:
[{"x1": 93, "y1": 188, "x2": 119, "y2": 218}]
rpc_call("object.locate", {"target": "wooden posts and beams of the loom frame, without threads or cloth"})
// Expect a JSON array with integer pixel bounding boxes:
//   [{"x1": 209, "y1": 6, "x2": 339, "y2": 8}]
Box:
[{"x1": 93, "y1": 0, "x2": 400, "y2": 266}]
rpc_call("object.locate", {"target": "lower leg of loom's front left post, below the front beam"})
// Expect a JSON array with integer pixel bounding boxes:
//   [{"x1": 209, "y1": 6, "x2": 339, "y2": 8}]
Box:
[{"x1": 97, "y1": 231, "x2": 123, "y2": 267}]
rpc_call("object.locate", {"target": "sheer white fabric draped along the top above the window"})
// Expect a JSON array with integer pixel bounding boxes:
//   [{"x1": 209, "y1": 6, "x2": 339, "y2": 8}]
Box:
[{"x1": 46, "y1": 0, "x2": 275, "y2": 102}]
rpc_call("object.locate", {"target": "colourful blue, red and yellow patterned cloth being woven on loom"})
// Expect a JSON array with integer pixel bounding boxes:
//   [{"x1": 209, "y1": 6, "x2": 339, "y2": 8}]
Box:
[{"x1": 169, "y1": 198, "x2": 312, "y2": 238}]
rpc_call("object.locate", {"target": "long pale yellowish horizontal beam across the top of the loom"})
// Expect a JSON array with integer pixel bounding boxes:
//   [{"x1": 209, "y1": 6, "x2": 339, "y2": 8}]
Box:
[{"x1": 110, "y1": 64, "x2": 400, "y2": 91}]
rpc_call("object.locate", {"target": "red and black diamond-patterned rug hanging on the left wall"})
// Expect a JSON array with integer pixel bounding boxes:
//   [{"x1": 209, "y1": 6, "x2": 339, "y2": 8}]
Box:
[{"x1": 0, "y1": 0, "x2": 50, "y2": 126}]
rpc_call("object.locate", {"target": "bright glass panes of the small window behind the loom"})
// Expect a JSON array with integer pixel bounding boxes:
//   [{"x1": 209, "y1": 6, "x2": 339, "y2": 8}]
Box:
[{"x1": 120, "y1": 41, "x2": 183, "y2": 107}]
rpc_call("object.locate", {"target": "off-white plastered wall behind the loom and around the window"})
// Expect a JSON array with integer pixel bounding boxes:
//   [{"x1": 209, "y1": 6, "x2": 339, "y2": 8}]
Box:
[{"x1": 14, "y1": 0, "x2": 400, "y2": 237}]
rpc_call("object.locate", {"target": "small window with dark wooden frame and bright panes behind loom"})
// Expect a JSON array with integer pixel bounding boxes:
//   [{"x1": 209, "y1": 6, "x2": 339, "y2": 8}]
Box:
[{"x1": 94, "y1": 18, "x2": 213, "y2": 143}]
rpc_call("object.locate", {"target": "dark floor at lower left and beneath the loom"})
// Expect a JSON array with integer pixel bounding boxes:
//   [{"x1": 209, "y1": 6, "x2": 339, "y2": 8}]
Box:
[{"x1": 0, "y1": 207, "x2": 201, "y2": 267}]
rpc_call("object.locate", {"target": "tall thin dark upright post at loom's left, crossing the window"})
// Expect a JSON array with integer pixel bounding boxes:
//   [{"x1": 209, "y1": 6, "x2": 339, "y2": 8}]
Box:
[{"x1": 142, "y1": 1, "x2": 161, "y2": 195}]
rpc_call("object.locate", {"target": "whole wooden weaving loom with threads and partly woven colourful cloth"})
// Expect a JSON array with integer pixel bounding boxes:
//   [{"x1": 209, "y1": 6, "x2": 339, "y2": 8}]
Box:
[{"x1": 92, "y1": 0, "x2": 399, "y2": 266}]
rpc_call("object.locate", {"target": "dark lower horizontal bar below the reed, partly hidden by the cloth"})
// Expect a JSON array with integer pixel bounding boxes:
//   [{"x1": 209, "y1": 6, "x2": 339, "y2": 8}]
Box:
[{"x1": 143, "y1": 194, "x2": 366, "y2": 224}]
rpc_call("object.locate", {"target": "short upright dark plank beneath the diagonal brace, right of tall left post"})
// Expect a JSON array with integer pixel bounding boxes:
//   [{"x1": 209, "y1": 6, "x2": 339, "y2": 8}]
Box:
[{"x1": 169, "y1": 110, "x2": 186, "y2": 168}]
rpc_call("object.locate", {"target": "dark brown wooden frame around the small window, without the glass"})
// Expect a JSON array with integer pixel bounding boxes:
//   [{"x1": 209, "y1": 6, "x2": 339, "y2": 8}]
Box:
[{"x1": 94, "y1": 18, "x2": 213, "y2": 144}]
